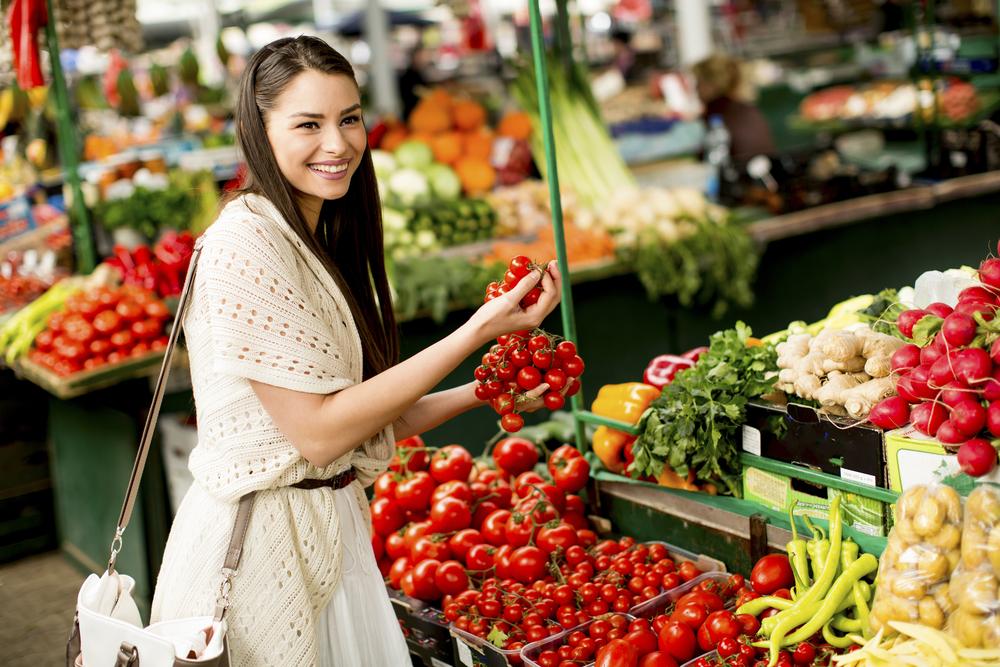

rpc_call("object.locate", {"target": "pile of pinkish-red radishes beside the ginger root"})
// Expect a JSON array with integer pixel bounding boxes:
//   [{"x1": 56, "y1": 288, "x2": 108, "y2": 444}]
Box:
[{"x1": 869, "y1": 247, "x2": 1000, "y2": 477}]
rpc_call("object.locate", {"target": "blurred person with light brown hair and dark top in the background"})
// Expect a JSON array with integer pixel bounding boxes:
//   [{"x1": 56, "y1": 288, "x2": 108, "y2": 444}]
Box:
[{"x1": 692, "y1": 53, "x2": 775, "y2": 162}]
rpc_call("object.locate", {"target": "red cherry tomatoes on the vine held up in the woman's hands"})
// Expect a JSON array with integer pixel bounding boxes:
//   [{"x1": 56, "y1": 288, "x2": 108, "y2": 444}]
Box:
[{"x1": 474, "y1": 255, "x2": 584, "y2": 433}]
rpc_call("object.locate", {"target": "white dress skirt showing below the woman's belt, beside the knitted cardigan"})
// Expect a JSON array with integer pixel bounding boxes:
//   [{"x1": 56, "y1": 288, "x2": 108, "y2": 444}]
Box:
[{"x1": 322, "y1": 489, "x2": 412, "y2": 667}]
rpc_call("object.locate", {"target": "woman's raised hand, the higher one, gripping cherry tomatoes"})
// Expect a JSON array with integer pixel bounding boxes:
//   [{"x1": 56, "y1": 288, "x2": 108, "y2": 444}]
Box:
[{"x1": 468, "y1": 261, "x2": 562, "y2": 343}]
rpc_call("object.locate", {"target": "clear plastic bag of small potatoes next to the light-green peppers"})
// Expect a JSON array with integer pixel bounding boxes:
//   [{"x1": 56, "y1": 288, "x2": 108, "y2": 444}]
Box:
[{"x1": 871, "y1": 485, "x2": 962, "y2": 632}]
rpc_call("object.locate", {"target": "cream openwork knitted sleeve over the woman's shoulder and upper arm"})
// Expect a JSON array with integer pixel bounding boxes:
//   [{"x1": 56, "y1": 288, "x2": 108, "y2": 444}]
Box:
[{"x1": 197, "y1": 215, "x2": 353, "y2": 394}]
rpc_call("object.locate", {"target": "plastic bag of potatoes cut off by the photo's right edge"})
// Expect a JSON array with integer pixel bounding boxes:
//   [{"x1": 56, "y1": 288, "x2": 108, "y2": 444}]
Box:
[{"x1": 948, "y1": 486, "x2": 1000, "y2": 648}]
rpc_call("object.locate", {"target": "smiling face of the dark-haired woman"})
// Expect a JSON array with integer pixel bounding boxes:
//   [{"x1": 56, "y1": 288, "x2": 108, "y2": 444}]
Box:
[{"x1": 266, "y1": 70, "x2": 368, "y2": 224}]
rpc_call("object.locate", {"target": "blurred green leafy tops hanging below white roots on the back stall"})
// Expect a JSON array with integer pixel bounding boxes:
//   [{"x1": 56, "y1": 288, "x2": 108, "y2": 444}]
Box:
[{"x1": 624, "y1": 219, "x2": 760, "y2": 317}]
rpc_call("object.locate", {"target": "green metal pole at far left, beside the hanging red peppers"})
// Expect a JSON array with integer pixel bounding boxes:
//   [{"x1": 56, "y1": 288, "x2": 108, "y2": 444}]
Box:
[{"x1": 45, "y1": 0, "x2": 97, "y2": 273}]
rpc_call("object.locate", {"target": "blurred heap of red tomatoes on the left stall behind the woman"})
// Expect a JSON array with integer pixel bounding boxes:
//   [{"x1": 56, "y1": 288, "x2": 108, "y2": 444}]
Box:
[{"x1": 28, "y1": 285, "x2": 170, "y2": 376}]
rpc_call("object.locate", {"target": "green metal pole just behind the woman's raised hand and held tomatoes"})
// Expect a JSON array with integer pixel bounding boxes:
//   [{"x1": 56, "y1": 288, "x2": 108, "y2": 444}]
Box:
[{"x1": 529, "y1": 0, "x2": 587, "y2": 452}]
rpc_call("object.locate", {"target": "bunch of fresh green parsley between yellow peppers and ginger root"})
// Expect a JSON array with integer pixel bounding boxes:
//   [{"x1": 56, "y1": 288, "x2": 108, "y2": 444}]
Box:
[{"x1": 632, "y1": 322, "x2": 777, "y2": 496}]
